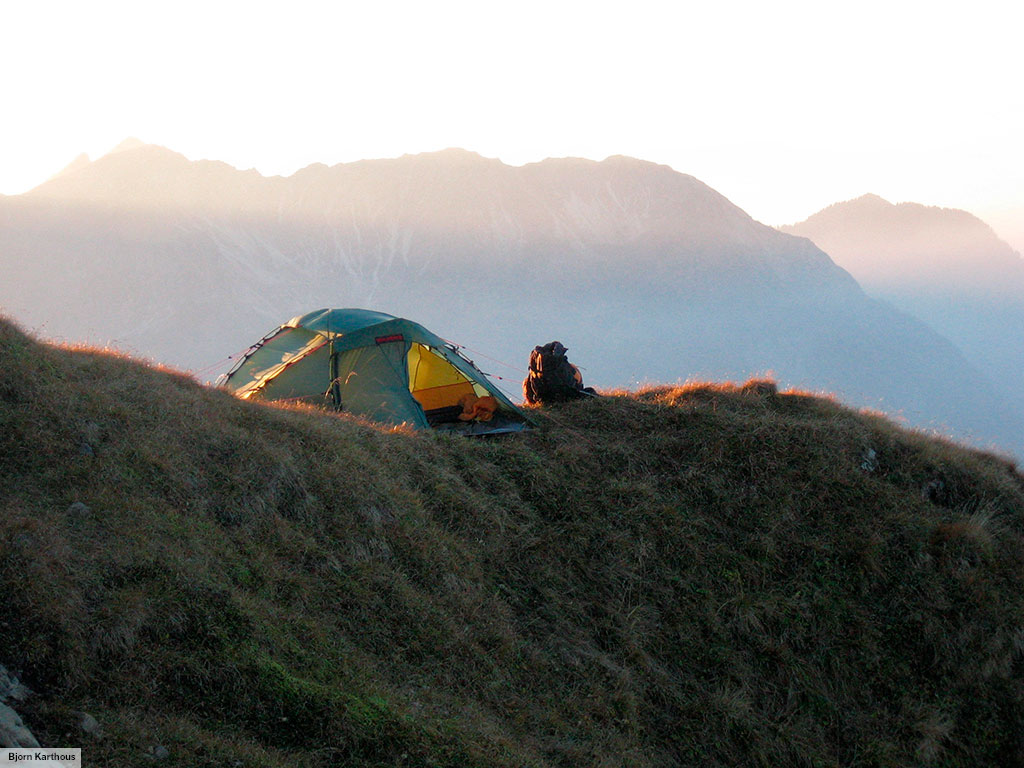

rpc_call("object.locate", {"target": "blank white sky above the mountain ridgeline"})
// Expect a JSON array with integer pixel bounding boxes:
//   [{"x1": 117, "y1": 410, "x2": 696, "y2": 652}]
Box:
[{"x1": 0, "y1": 0, "x2": 1024, "y2": 251}]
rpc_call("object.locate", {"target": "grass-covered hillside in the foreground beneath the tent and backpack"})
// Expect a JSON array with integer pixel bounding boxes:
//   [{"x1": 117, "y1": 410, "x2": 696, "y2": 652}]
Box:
[{"x1": 0, "y1": 315, "x2": 1024, "y2": 768}]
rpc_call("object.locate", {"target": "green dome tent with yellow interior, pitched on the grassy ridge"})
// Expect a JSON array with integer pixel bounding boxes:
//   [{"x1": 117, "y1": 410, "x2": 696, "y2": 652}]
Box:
[{"x1": 218, "y1": 309, "x2": 527, "y2": 434}]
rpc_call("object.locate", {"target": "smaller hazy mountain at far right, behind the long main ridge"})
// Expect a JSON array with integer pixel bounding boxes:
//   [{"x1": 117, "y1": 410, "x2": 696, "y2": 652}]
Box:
[{"x1": 783, "y1": 195, "x2": 1024, "y2": 393}]
